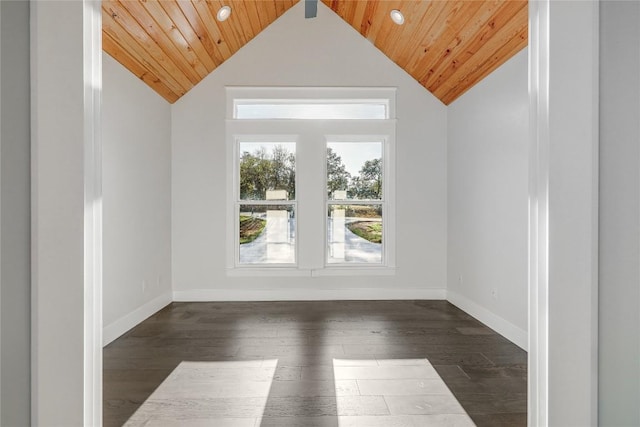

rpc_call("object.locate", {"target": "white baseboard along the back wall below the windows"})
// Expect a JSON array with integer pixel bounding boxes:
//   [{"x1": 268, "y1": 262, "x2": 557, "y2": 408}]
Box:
[{"x1": 173, "y1": 288, "x2": 446, "y2": 302}]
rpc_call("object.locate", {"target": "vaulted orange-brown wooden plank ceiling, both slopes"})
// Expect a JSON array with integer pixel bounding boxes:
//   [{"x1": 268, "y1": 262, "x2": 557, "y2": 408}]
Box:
[{"x1": 102, "y1": 0, "x2": 528, "y2": 105}]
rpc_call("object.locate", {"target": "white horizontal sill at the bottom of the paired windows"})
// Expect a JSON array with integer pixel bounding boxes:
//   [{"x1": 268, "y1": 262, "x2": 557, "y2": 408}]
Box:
[{"x1": 227, "y1": 267, "x2": 396, "y2": 277}]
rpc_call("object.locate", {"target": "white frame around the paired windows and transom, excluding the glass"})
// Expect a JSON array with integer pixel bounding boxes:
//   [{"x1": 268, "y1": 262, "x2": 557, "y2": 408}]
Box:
[{"x1": 225, "y1": 87, "x2": 396, "y2": 277}]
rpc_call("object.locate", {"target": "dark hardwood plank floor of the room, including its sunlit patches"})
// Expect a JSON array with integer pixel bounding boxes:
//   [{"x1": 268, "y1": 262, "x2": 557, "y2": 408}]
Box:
[{"x1": 103, "y1": 301, "x2": 527, "y2": 427}]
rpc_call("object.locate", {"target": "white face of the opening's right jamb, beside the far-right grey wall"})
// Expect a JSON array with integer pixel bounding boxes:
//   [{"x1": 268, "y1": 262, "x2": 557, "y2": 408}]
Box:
[{"x1": 544, "y1": 1, "x2": 599, "y2": 427}]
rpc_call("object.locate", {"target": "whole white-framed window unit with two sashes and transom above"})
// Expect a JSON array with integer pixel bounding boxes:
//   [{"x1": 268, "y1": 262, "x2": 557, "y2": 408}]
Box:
[{"x1": 226, "y1": 87, "x2": 395, "y2": 276}]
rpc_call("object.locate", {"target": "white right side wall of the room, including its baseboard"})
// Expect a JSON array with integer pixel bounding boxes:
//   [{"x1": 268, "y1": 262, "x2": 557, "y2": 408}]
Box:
[{"x1": 447, "y1": 49, "x2": 529, "y2": 348}]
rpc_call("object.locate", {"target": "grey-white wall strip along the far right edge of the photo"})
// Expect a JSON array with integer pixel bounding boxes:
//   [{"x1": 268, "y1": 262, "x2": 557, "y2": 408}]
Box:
[{"x1": 599, "y1": 1, "x2": 640, "y2": 427}]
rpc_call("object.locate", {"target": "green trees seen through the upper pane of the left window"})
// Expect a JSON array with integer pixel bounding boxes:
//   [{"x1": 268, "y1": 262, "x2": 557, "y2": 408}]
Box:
[{"x1": 240, "y1": 145, "x2": 296, "y2": 200}]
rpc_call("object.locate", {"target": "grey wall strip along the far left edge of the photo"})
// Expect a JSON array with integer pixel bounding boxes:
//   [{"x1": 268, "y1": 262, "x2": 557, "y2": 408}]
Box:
[{"x1": 0, "y1": 1, "x2": 31, "y2": 426}]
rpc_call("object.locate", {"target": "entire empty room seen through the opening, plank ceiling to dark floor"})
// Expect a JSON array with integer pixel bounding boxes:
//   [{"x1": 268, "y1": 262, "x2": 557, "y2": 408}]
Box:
[{"x1": 102, "y1": 1, "x2": 529, "y2": 427}]
